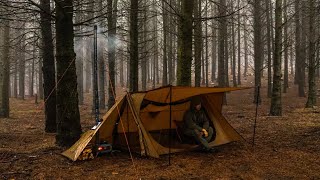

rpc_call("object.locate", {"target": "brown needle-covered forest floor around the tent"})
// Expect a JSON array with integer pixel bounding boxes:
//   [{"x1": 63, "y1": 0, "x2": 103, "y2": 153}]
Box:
[{"x1": 0, "y1": 76, "x2": 320, "y2": 179}]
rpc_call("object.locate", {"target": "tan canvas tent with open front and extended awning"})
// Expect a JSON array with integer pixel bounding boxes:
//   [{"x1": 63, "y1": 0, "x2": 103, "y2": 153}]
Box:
[{"x1": 62, "y1": 86, "x2": 245, "y2": 161}]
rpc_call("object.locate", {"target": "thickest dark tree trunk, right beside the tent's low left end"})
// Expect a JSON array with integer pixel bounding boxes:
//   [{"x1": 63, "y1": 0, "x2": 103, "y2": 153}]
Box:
[{"x1": 56, "y1": 0, "x2": 81, "y2": 146}]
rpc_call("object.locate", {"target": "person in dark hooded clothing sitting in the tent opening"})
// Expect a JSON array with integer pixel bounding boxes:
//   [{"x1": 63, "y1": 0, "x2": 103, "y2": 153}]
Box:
[{"x1": 183, "y1": 96, "x2": 214, "y2": 152}]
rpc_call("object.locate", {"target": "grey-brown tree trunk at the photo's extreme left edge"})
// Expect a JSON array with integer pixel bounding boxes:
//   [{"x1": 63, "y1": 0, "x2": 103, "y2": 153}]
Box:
[{"x1": 0, "y1": 17, "x2": 10, "y2": 118}]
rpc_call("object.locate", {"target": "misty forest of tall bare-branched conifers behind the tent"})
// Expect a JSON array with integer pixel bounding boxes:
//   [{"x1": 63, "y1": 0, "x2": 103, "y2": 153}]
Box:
[{"x1": 0, "y1": 0, "x2": 320, "y2": 146}]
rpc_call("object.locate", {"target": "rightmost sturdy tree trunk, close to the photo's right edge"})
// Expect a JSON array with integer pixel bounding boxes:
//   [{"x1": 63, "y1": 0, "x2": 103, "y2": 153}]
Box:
[{"x1": 306, "y1": 0, "x2": 317, "y2": 108}]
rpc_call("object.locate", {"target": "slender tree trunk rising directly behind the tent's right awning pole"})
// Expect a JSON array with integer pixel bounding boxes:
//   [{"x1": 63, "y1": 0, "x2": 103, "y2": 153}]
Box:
[{"x1": 253, "y1": 0, "x2": 263, "y2": 103}]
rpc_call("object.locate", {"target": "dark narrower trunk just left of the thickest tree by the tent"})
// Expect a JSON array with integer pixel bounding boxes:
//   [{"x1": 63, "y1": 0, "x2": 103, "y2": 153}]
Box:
[{"x1": 39, "y1": 0, "x2": 57, "y2": 133}]
